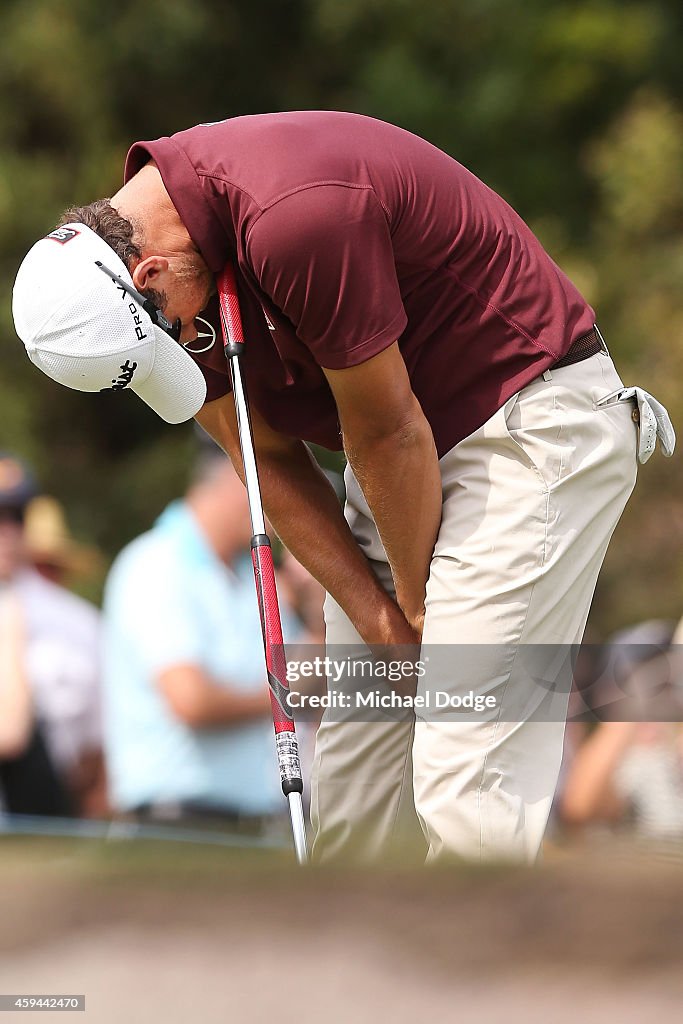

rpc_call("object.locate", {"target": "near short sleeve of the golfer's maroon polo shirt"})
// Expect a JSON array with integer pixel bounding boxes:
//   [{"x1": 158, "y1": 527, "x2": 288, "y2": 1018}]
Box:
[{"x1": 247, "y1": 183, "x2": 408, "y2": 370}]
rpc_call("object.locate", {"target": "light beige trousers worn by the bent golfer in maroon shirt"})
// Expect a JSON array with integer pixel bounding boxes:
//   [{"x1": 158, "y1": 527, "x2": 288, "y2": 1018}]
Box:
[{"x1": 311, "y1": 352, "x2": 636, "y2": 862}]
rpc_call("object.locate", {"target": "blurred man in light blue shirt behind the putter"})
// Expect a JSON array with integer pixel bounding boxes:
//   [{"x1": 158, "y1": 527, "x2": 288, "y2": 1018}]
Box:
[{"x1": 100, "y1": 449, "x2": 301, "y2": 833}]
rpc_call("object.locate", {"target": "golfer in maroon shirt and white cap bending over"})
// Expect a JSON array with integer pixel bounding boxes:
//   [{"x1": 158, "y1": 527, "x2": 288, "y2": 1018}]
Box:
[{"x1": 14, "y1": 112, "x2": 671, "y2": 859}]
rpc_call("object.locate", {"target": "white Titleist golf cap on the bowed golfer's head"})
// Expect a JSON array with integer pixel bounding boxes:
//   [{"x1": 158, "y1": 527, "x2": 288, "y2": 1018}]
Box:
[{"x1": 12, "y1": 224, "x2": 206, "y2": 423}]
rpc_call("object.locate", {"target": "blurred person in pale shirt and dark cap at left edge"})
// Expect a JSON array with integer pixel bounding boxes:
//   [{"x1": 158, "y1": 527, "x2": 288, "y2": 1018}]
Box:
[{"x1": 0, "y1": 454, "x2": 104, "y2": 814}]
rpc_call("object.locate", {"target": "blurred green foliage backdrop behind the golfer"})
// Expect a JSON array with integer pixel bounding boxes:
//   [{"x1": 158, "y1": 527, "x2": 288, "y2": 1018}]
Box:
[{"x1": 0, "y1": 0, "x2": 683, "y2": 633}]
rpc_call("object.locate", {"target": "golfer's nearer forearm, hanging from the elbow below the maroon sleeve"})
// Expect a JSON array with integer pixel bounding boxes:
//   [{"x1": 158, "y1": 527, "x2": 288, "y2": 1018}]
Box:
[{"x1": 345, "y1": 418, "x2": 441, "y2": 631}]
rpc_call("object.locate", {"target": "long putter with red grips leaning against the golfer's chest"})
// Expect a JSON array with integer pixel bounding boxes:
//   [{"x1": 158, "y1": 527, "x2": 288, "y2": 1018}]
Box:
[{"x1": 217, "y1": 263, "x2": 307, "y2": 864}]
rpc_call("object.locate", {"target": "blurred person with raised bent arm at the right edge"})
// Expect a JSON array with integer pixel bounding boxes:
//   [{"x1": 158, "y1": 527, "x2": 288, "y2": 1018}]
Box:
[{"x1": 560, "y1": 622, "x2": 683, "y2": 840}]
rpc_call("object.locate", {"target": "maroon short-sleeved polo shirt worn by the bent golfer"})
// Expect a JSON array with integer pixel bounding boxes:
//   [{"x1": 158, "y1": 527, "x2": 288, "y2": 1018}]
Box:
[{"x1": 125, "y1": 111, "x2": 594, "y2": 456}]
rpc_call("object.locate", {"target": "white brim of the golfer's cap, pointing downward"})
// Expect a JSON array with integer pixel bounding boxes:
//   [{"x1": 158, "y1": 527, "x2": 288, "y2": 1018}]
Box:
[{"x1": 130, "y1": 325, "x2": 206, "y2": 423}]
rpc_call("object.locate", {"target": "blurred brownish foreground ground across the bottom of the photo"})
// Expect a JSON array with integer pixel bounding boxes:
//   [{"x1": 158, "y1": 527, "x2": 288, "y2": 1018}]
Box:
[{"x1": 0, "y1": 837, "x2": 683, "y2": 1024}]
